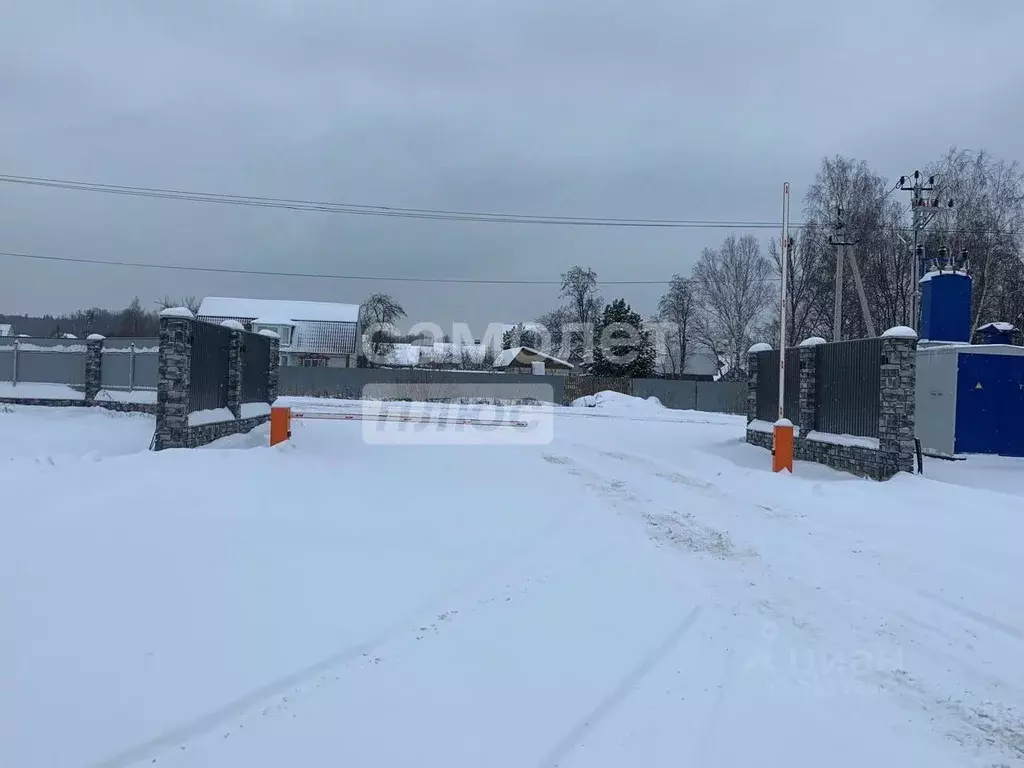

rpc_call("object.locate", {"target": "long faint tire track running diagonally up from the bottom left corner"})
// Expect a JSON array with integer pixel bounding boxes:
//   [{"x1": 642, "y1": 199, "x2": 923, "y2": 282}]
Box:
[{"x1": 90, "y1": 501, "x2": 580, "y2": 768}]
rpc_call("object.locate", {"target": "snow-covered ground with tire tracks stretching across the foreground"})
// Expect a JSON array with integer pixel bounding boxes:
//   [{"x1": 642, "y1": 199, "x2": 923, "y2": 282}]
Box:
[{"x1": 0, "y1": 398, "x2": 1024, "y2": 768}]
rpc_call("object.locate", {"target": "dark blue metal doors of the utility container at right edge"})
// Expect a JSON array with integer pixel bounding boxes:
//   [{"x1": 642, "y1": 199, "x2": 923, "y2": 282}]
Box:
[{"x1": 953, "y1": 353, "x2": 1024, "y2": 456}]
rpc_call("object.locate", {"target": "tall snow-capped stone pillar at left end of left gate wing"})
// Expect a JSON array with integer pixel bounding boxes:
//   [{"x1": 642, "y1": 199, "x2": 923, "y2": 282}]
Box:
[{"x1": 153, "y1": 307, "x2": 195, "y2": 451}]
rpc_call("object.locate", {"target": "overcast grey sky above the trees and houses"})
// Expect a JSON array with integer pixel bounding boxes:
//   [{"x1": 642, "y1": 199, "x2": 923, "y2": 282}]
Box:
[{"x1": 0, "y1": 0, "x2": 1024, "y2": 328}]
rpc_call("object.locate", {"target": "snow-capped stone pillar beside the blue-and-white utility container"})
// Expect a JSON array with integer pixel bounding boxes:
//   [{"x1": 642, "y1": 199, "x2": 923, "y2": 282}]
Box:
[{"x1": 879, "y1": 326, "x2": 918, "y2": 479}]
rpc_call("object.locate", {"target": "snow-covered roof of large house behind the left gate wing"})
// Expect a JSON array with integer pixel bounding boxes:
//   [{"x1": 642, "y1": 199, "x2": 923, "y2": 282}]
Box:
[{"x1": 199, "y1": 296, "x2": 359, "y2": 354}]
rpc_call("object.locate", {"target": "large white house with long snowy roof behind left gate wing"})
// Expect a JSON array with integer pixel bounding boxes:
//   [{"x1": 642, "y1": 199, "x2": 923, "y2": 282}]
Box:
[{"x1": 198, "y1": 296, "x2": 359, "y2": 368}]
